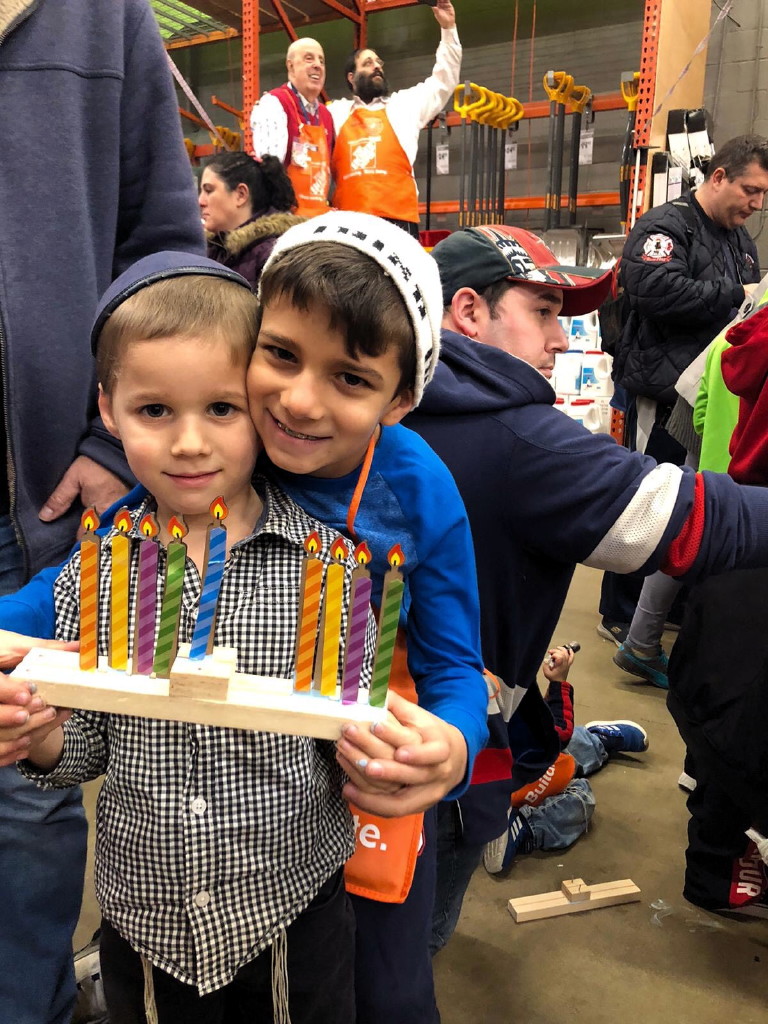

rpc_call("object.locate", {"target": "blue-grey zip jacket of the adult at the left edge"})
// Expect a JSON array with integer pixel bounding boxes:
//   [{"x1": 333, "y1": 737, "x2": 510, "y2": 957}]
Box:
[{"x1": 0, "y1": 0, "x2": 204, "y2": 572}]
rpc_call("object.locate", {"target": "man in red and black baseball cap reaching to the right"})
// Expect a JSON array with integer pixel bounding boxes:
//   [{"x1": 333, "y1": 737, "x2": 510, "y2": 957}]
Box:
[{"x1": 404, "y1": 225, "x2": 768, "y2": 940}]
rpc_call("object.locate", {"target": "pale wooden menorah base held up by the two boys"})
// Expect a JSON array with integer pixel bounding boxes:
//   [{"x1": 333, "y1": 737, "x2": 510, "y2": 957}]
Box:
[{"x1": 13, "y1": 645, "x2": 387, "y2": 739}]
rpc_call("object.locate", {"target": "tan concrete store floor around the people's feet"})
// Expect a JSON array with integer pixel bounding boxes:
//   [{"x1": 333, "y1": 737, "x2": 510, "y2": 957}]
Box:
[{"x1": 76, "y1": 568, "x2": 768, "y2": 1024}]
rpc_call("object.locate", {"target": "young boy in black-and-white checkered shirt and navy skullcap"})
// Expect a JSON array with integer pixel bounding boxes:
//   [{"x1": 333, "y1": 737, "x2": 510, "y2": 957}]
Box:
[{"x1": 0, "y1": 253, "x2": 384, "y2": 1024}]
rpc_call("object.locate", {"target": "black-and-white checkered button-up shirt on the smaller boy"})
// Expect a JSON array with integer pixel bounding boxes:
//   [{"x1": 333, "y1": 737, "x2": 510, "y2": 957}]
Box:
[{"x1": 25, "y1": 481, "x2": 374, "y2": 994}]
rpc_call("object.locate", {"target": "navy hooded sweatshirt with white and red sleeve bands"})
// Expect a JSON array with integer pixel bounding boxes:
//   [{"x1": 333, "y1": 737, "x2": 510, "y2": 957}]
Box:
[{"x1": 404, "y1": 331, "x2": 768, "y2": 781}]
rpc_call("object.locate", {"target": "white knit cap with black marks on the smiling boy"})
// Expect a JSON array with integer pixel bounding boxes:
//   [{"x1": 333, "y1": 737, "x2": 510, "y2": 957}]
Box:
[{"x1": 262, "y1": 210, "x2": 442, "y2": 407}]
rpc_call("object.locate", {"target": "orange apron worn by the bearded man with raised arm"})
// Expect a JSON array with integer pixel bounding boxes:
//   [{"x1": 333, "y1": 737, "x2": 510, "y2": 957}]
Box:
[{"x1": 332, "y1": 108, "x2": 419, "y2": 223}]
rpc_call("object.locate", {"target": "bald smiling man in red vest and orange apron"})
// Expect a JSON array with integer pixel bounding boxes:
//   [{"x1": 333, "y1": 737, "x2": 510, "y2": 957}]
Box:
[{"x1": 251, "y1": 39, "x2": 335, "y2": 217}]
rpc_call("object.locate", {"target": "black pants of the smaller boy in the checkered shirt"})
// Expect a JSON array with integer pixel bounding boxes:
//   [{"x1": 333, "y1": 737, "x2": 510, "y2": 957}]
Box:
[{"x1": 100, "y1": 870, "x2": 355, "y2": 1024}]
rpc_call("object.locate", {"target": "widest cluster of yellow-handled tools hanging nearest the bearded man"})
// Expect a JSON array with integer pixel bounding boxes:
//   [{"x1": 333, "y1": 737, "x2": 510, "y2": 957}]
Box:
[{"x1": 454, "y1": 82, "x2": 523, "y2": 227}]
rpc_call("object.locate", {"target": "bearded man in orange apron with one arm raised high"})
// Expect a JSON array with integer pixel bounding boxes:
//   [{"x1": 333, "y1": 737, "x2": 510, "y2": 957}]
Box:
[{"x1": 329, "y1": 0, "x2": 462, "y2": 238}]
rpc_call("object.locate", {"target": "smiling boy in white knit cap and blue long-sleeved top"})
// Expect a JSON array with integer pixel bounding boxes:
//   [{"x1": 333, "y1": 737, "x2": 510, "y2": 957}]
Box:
[{"x1": 256, "y1": 212, "x2": 487, "y2": 1024}]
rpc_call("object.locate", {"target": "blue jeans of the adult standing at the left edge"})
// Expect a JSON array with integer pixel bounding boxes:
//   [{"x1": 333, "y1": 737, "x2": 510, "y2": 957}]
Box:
[{"x1": 0, "y1": 515, "x2": 87, "y2": 1024}]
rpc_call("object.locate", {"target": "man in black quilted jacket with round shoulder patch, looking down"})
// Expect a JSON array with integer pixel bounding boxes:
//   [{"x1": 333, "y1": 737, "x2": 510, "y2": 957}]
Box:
[{"x1": 598, "y1": 135, "x2": 768, "y2": 645}]
